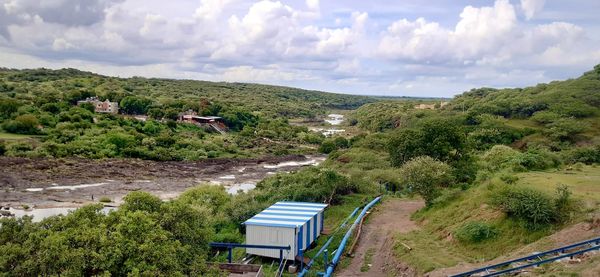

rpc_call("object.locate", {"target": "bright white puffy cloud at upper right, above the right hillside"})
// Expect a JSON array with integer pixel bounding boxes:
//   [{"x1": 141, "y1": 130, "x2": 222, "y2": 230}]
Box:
[{"x1": 379, "y1": 0, "x2": 587, "y2": 69}]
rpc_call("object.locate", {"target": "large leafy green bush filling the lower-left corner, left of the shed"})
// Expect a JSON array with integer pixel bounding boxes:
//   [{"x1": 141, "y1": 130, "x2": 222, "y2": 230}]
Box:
[{"x1": 0, "y1": 192, "x2": 219, "y2": 276}]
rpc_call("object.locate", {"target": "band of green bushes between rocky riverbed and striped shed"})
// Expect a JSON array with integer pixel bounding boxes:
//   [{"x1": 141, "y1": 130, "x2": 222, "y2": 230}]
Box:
[{"x1": 0, "y1": 165, "x2": 368, "y2": 276}]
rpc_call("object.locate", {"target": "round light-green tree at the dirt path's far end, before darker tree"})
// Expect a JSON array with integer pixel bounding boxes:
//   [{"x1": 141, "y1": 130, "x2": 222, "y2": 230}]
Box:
[{"x1": 400, "y1": 156, "x2": 452, "y2": 206}]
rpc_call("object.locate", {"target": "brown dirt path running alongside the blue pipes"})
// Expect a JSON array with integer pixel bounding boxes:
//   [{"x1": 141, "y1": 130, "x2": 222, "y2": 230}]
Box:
[{"x1": 335, "y1": 198, "x2": 424, "y2": 276}]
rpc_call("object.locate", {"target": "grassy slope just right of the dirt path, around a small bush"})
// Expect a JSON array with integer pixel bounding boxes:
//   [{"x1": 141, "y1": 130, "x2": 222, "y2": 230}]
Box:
[{"x1": 394, "y1": 180, "x2": 564, "y2": 273}]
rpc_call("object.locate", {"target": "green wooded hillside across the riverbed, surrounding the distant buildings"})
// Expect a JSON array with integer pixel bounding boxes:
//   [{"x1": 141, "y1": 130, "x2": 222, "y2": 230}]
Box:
[{"x1": 0, "y1": 69, "x2": 374, "y2": 161}]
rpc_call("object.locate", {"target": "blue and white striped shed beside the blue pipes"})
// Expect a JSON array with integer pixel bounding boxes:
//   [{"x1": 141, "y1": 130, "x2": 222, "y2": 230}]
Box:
[{"x1": 243, "y1": 201, "x2": 327, "y2": 260}]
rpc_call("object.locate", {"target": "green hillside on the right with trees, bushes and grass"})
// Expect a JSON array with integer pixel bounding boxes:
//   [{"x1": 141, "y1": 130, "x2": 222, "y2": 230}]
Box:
[{"x1": 326, "y1": 66, "x2": 600, "y2": 274}]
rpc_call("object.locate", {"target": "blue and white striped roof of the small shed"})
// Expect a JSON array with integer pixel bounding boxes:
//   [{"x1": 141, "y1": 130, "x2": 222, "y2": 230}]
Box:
[{"x1": 243, "y1": 201, "x2": 327, "y2": 228}]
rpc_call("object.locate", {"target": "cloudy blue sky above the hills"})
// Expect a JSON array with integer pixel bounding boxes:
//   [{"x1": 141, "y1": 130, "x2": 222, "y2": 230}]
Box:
[{"x1": 0, "y1": 0, "x2": 600, "y2": 96}]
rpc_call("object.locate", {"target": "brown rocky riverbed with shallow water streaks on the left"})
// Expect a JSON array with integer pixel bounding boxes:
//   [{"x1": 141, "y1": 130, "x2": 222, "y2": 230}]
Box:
[{"x1": 0, "y1": 155, "x2": 325, "y2": 208}]
